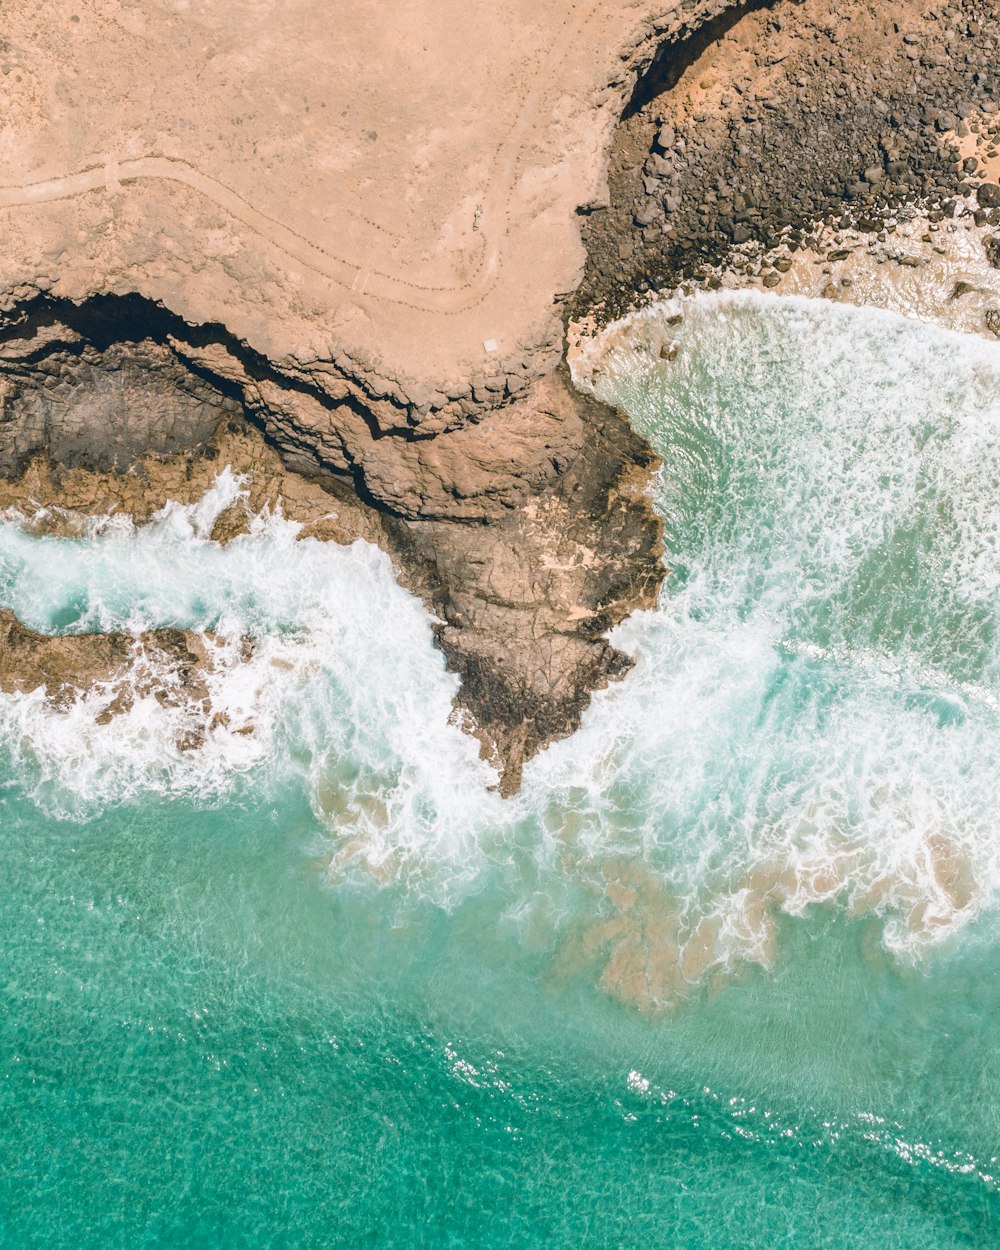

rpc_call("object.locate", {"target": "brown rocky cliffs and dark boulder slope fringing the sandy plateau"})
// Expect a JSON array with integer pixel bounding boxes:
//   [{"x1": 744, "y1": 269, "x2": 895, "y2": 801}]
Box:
[{"x1": 0, "y1": 0, "x2": 1000, "y2": 794}]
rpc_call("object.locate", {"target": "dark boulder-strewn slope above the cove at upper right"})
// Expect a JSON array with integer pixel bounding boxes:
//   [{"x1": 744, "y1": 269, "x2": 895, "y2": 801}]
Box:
[{"x1": 569, "y1": 0, "x2": 1000, "y2": 319}]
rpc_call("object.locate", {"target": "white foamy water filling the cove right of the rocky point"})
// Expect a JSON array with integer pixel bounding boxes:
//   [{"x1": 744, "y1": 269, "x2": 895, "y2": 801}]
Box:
[{"x1": 533, "y1": 286, "x2": 1000, "y2": 993}]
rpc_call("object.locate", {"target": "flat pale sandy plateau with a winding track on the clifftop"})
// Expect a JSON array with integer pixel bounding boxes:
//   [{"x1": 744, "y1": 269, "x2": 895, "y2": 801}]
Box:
[{"x1": 0, "y1": 0, "x2": 720, "y2": 393}]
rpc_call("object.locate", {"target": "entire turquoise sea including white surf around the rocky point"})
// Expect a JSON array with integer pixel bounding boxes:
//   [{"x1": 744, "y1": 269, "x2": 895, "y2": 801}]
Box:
[{"x1": 0, "y1": 296, "x2": 1000, "y2": 1250}]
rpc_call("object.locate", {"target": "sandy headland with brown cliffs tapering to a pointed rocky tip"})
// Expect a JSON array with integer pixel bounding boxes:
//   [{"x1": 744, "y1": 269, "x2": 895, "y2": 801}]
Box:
[{"x1": 0, "y1": 0, "x2": 740, "y2": 793}]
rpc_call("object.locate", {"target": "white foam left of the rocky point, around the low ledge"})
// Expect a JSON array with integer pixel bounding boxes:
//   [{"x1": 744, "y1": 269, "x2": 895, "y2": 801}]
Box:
[{"x1": 0, "y1": 473, "x2": 495, "y2": 863}]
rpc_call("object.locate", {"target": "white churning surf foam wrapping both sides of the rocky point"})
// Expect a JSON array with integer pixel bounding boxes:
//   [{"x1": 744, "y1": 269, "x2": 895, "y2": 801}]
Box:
[{"x1": 0, "y1": 295, "x2": 1000, "y2": 1011}]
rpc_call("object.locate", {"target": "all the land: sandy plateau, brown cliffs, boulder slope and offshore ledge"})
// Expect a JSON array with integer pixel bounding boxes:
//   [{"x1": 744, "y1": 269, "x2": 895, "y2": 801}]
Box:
[{"x1": 0, "y1": 0, "x2": 1000, "y2": 793}]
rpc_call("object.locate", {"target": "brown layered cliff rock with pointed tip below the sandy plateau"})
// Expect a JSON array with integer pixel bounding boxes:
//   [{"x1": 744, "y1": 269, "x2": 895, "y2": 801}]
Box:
[{"x1": 0, "y1": 296, "x2": 663, "y2": 794}]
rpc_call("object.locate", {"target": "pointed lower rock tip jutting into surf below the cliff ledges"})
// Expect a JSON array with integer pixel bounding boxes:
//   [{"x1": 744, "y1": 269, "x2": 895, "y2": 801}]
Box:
[{"x1": 396, "y1": 370, "x2": 664, "y2": 793}]
